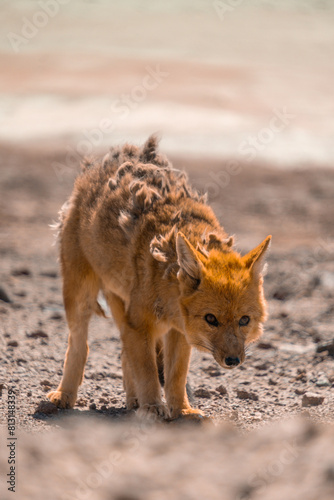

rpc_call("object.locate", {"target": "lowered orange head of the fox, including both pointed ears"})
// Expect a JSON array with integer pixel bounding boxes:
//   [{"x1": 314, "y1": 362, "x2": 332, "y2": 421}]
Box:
[{"x1": 176, "y1": 232, "x2": 271, "y2": 368}]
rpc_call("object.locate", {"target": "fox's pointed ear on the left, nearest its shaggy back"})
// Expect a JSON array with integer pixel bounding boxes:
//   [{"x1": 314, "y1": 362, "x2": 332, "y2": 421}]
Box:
[{"x1": 176, "y1": 232, "x2": 203, "y2": 287}]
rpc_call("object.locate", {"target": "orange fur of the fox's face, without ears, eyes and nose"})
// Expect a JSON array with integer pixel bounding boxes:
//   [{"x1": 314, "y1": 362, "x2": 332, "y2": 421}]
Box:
[{"x1": 180, "y1": 250, "x2": 266, "y2": 367}]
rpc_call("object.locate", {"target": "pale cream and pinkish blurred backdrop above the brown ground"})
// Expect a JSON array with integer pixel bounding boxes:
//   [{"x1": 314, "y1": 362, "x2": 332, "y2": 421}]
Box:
[{"x1": 0, "y1": 0, "x2": 334, "y2": 162}]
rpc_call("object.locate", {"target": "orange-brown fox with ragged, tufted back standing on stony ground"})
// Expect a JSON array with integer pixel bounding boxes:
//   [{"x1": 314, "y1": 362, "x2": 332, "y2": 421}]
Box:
[{"x1": 48, "y1": 135, "x2": 271, "y2": 420}]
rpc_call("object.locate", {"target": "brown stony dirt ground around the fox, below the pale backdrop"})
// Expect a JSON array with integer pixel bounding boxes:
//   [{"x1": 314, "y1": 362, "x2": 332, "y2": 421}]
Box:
[{"x1": 0, "y1": 146, "x2": 334, "y2": 500}]
